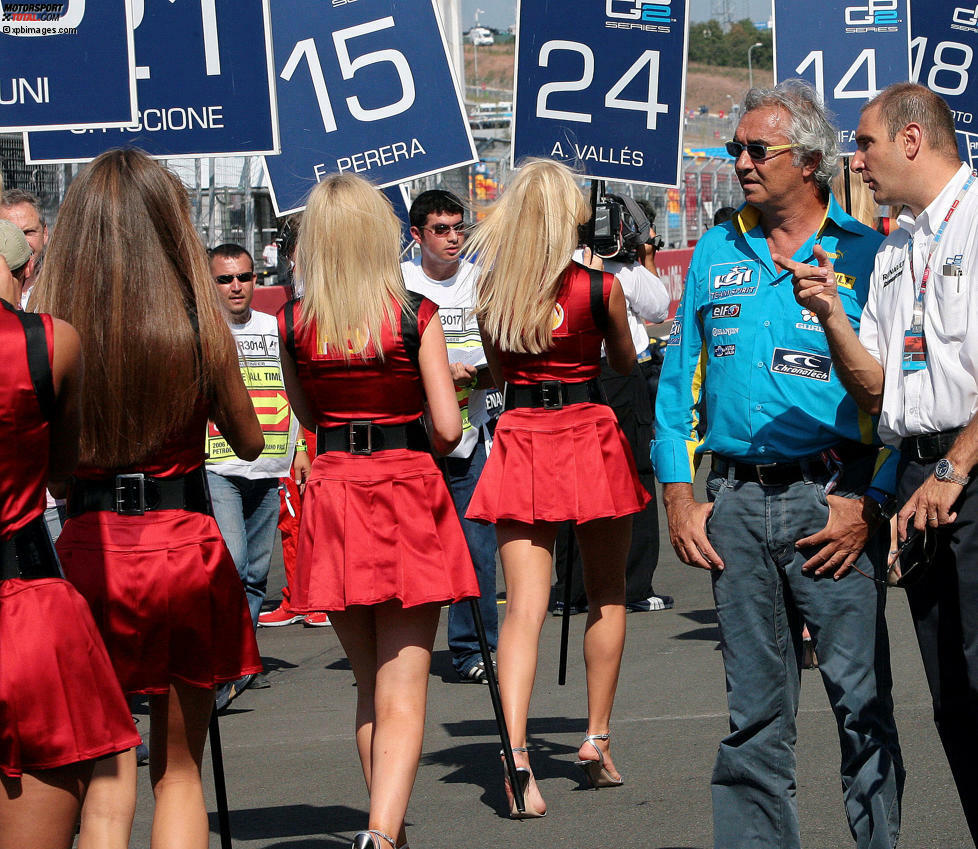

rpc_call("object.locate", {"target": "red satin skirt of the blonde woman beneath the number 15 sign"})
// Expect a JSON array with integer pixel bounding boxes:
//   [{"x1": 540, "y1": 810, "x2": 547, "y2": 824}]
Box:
[{"x1": 291, "y1": 449, "x2": 479, "y2": 613}]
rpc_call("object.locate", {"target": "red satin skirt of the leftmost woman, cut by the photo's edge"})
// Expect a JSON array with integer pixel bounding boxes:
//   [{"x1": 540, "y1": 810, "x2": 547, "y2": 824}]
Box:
[{"x1": 0, "y1": 578, "x2": 139, "y2": 778}]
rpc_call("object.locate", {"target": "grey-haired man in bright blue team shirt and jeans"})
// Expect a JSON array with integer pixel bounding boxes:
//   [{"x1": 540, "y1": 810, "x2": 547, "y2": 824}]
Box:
[{"x1": 653, "y1": 81, "x2": 904, "y2": 849}]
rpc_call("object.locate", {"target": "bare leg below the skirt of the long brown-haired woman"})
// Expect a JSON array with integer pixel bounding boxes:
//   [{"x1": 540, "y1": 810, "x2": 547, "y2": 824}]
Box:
[{"x1": 149, "y1": 681, "x2": 214, "y2": 849}]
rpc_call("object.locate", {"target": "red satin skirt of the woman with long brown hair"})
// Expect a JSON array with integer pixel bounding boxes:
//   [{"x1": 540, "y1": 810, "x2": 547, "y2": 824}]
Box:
[{"x1": 57, "y1": 510, "x2": 262, "y2": 693}]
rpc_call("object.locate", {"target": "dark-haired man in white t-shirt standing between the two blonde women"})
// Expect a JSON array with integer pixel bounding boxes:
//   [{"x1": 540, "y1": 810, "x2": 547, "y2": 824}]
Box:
[{"x1": 401, "y1": 189, "x2": 502, "y2": 684}]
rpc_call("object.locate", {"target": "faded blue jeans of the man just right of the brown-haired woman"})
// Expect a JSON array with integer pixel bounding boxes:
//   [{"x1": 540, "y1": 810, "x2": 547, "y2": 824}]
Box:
[{"x1": 207, "y1": 472, "x2": 279, "y2": 628}]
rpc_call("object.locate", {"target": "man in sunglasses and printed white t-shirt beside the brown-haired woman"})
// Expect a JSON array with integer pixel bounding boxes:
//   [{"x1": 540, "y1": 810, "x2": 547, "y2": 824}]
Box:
[{"x1": 206, "y1": 244, "x2": 310, "y2": 708}]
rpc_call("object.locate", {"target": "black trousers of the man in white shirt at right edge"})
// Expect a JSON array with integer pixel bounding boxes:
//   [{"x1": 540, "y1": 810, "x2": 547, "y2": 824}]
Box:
[{"x1": 897, "y1": 458, "x2": 978, "y2": 844}]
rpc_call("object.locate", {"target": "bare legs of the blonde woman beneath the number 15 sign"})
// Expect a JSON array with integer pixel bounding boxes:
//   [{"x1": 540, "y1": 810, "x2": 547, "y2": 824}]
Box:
[{"x1": 330, "y1": 602, "x2": 440, "y2": 845}]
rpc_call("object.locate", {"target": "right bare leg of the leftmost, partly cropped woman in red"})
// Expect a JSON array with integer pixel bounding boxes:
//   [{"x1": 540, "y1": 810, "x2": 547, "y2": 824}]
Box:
[{"x1": 78, "y1": 749, "x2": 136, "y2": 849}]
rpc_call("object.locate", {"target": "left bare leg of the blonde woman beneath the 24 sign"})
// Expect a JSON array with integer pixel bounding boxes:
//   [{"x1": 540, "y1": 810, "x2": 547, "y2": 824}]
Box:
[{"x1": 496, "y1": 521, "x2": 557, "y2": 813}]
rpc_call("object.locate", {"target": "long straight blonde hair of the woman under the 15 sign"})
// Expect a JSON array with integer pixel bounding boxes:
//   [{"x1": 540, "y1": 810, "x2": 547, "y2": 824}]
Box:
[{"x1": 295, "y1": 174, "x2": 408, "y2": 362}]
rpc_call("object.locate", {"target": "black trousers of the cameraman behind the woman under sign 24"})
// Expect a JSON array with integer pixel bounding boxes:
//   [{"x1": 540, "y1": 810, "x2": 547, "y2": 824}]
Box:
[{"x1": 554, "y1": 360, "x2": 661, "y2": 606}]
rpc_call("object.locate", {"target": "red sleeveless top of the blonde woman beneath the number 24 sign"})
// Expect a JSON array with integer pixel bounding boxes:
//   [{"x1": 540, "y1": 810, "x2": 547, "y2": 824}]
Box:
[{"x1": 496, "y1": 263, "x2": 615, "y2": 383}]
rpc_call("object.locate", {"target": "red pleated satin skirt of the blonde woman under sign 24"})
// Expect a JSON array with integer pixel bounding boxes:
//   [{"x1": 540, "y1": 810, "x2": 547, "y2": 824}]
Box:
[{"x1": 465, "y1": 404, "x2": 650, "y2": 524}]
